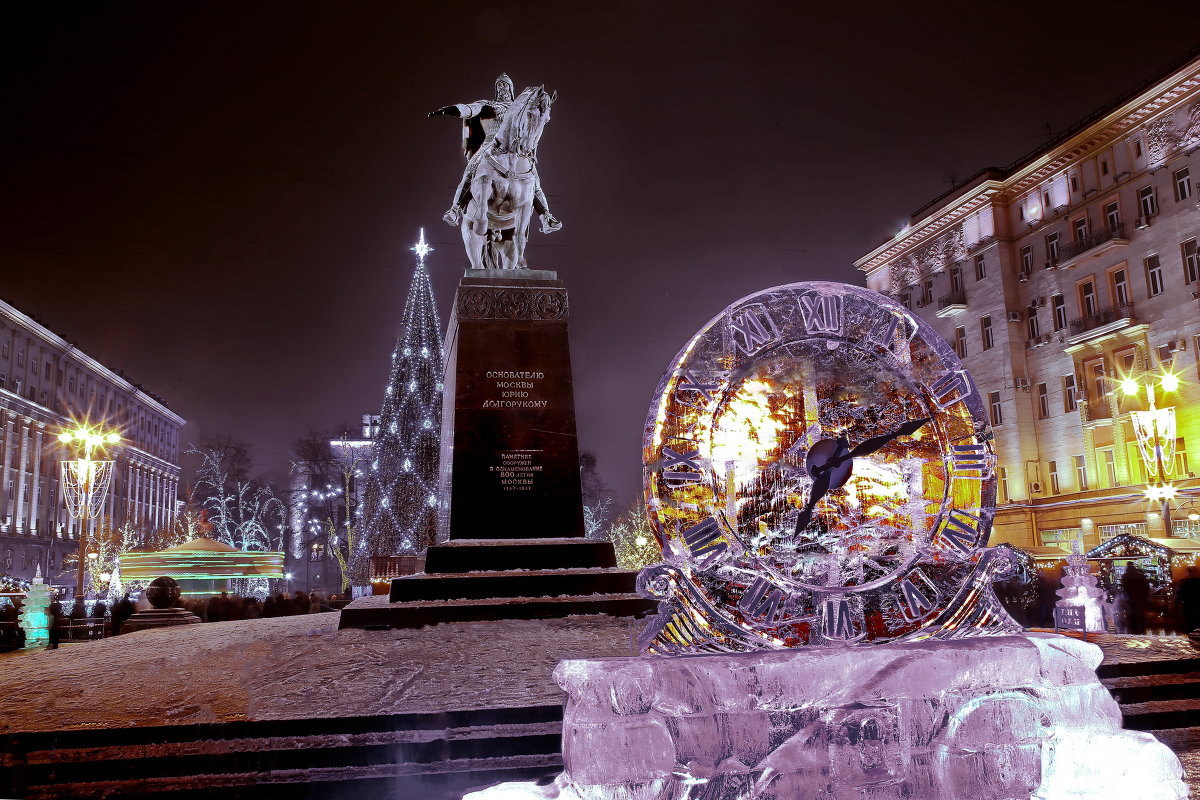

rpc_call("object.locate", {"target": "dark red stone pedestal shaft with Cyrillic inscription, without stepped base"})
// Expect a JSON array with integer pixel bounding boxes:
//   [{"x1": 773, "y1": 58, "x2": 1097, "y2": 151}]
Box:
[{"x1": 442, "y1": 272, "x2": 583, "y2": 539}]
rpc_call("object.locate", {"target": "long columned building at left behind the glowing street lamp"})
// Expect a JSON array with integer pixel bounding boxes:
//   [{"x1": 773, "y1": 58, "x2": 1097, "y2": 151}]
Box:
[{"x1": 0, "y1": 301, "x2": 186, "y2": 585}]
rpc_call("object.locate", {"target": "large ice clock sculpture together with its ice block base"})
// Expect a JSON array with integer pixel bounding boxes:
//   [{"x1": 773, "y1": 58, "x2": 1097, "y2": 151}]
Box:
[{"x1": 468, "y1": 282, "x2": 1187, "y2": 800}]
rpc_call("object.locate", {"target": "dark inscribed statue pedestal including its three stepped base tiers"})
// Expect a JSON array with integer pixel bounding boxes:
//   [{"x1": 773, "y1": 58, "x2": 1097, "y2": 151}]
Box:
[{"x1": 338, "y1": 270, "x2": 656, "y2": 627}]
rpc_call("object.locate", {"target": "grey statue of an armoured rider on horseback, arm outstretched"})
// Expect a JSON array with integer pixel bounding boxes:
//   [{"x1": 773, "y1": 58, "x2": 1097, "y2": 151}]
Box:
[{"x1": 428, "y1": 74, "x2": 563, "y2": 270}]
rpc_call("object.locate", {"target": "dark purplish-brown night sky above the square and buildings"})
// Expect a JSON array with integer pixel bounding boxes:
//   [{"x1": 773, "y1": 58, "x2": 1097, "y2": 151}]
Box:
[{"x1": 0, "y1": 1, "x2": 1198, "y2": 500}]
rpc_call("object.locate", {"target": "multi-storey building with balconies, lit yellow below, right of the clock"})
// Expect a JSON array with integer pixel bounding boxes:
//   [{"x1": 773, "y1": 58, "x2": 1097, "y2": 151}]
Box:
[{"x1": 854, "y1": 52, "x2": 1200, "y2": 547}]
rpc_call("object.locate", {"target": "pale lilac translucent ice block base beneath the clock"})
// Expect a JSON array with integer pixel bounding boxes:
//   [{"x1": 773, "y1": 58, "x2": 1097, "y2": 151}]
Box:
[{"x1": 468, "y1": 634, "x2": 1187, "y2": 800}]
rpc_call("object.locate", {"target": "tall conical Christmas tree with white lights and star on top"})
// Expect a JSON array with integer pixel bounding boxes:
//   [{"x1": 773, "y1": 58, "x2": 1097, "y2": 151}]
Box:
[{"x1": 362, "y1": 229, "x2": 442, "y2": 555}]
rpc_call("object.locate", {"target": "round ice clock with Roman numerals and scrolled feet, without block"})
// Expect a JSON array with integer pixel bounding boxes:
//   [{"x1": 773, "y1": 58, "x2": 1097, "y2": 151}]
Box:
[{"x1": 640, "y1": 282, "x2": 1020, "y2": 654}]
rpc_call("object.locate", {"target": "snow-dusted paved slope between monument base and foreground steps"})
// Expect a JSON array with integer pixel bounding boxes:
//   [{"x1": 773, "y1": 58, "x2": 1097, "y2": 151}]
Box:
[{"x1": 0, "y1": 609, "x2": 636, "y2": 733}]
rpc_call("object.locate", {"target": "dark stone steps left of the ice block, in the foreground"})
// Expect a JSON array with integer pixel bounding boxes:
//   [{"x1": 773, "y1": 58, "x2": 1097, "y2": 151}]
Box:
[{"x1": 0, "y1": 705, "x2": 563, "y2": 800}]
